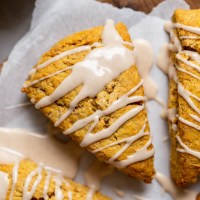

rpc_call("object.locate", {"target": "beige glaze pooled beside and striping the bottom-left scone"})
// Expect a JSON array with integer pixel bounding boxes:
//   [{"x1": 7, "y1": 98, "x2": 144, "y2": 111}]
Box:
[{"x1": 0, "y1": 128, "x2": 108, "y2": 200}]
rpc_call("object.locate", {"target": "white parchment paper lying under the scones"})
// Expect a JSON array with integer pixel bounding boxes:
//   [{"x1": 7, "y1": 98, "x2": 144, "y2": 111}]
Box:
[{"x1": 0, "y1": 0, "x2": 200, "y2": 200}]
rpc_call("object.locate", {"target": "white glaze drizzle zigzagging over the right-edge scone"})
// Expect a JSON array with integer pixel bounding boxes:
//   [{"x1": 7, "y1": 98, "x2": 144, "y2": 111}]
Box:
[{"x1": 163, "y1": 22, "x2": 200, "y2": 158}]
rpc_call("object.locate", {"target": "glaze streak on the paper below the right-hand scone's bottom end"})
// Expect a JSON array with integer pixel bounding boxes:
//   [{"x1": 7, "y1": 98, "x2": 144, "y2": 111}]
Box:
[{"x1": 155, "y1": 172, "x2": 198, "y2": 200}]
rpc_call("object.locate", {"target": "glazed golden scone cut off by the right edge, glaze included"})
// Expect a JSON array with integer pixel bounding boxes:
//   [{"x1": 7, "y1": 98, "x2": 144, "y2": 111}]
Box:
[{"x1": 165, "y1": 9, "x2": 200, "y2": 185}]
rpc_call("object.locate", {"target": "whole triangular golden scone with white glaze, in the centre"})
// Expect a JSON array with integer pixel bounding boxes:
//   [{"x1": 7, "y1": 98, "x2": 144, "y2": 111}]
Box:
[{"x1": 22, "y1": 20, "x2": 154, "y2": 183}]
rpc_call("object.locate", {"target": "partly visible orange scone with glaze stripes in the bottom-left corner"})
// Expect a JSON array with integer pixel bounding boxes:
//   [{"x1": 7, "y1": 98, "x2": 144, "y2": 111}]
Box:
[{"x1": 0, "y1": 160, "x2": 110, "y2": 200}]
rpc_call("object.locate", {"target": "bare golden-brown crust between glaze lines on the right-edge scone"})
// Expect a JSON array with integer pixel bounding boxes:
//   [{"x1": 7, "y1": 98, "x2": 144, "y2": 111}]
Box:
[{"x1": 169, "y1": 10, "x2": 200, "y2": 185}]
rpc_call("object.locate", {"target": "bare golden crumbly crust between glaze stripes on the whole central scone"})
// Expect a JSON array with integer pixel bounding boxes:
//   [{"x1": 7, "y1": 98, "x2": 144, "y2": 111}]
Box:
[{"x1": 22, "y1": 23, "x2": 154, "y2": 183}]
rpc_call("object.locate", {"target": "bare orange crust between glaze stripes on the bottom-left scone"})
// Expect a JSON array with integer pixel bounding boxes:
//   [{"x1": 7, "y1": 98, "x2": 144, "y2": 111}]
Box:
[{"x1": 0, "y1": 160, "x2": 110, "y2": 200}]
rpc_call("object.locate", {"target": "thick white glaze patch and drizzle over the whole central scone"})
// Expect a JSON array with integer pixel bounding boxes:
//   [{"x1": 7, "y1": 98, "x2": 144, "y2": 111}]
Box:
[{"x1": 26, "y1": 20, "x2": 154, "y2": 167}]
